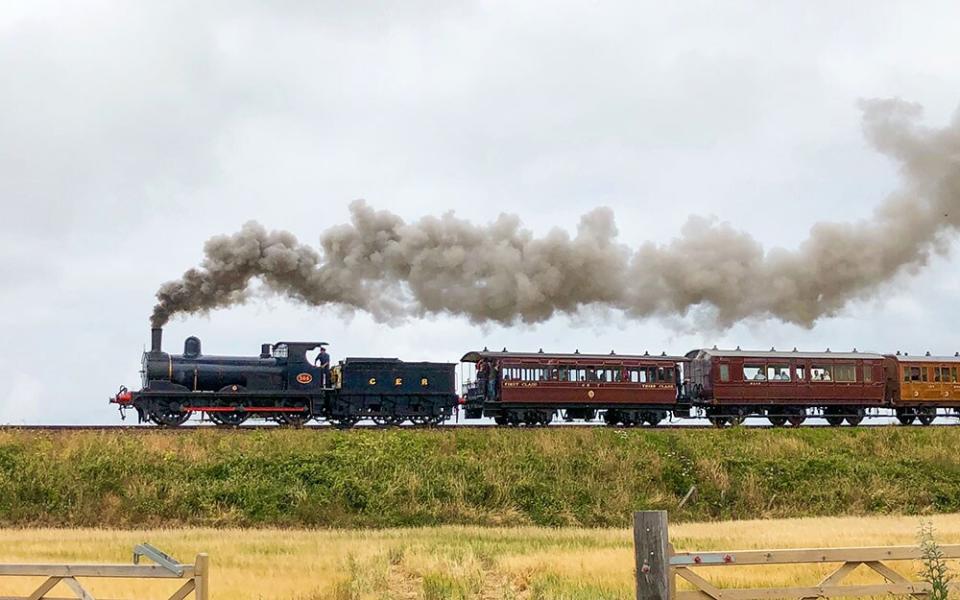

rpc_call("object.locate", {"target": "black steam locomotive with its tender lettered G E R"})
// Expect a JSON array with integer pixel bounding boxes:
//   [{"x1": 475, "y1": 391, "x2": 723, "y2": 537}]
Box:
[{"x1": 110, "y1": 329, "x2": 458, "y2": 427}]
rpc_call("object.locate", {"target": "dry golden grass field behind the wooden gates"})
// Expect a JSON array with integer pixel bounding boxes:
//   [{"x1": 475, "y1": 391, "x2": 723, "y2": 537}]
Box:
[{"x1": 0, "y1": 515, "x2": 960, "y2": 600}]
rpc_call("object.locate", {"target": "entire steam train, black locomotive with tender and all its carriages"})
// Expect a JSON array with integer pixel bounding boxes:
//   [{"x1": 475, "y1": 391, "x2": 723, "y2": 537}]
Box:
[{"x1": 110, "y1": 329, "x2": 960, "y2": 427}]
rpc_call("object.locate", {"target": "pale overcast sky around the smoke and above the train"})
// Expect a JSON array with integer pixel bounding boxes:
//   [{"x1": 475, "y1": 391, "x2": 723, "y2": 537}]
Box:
[{"x1": 0, "y1": 0, "x2": 960, "y2": 423}]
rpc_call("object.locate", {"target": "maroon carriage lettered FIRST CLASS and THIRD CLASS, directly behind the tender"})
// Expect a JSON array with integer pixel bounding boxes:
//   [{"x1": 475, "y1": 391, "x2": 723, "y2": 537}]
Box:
[{"x1": 462, "y1": 350, "x2": 689, "y2": 426}]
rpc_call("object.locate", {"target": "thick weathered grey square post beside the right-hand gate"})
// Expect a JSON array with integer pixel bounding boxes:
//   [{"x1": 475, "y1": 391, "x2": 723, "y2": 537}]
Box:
[{"x1": 633, "y1": 510, "x2": 672, "y2": 600}]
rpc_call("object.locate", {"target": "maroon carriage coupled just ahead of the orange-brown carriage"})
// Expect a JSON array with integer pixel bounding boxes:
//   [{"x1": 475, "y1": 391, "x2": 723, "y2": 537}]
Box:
[{"x1": 687, "y1": 348, "x2": 888, "y2": 426}]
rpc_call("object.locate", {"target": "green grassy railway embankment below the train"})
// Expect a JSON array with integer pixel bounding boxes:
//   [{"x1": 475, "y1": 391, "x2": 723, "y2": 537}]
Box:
[{"x1": 0, "y1": 426, "x2": 960, "y2": 528}]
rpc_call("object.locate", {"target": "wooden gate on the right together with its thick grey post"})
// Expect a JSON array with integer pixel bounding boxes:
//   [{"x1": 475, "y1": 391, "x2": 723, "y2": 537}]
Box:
[{"x1": 633, "y1": 511, "x2": 960, "y2": 600}]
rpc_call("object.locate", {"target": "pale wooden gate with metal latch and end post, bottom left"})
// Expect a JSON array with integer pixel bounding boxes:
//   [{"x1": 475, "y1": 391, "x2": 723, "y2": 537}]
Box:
[{"x1": 0, "y1": 544, "x2": 210, "y2": 600}]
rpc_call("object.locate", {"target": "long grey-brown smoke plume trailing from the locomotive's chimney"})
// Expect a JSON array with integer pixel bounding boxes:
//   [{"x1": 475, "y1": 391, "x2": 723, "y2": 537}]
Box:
[{"x1": 152, "y1": 100, "x2": 960, "y2": 327}]
